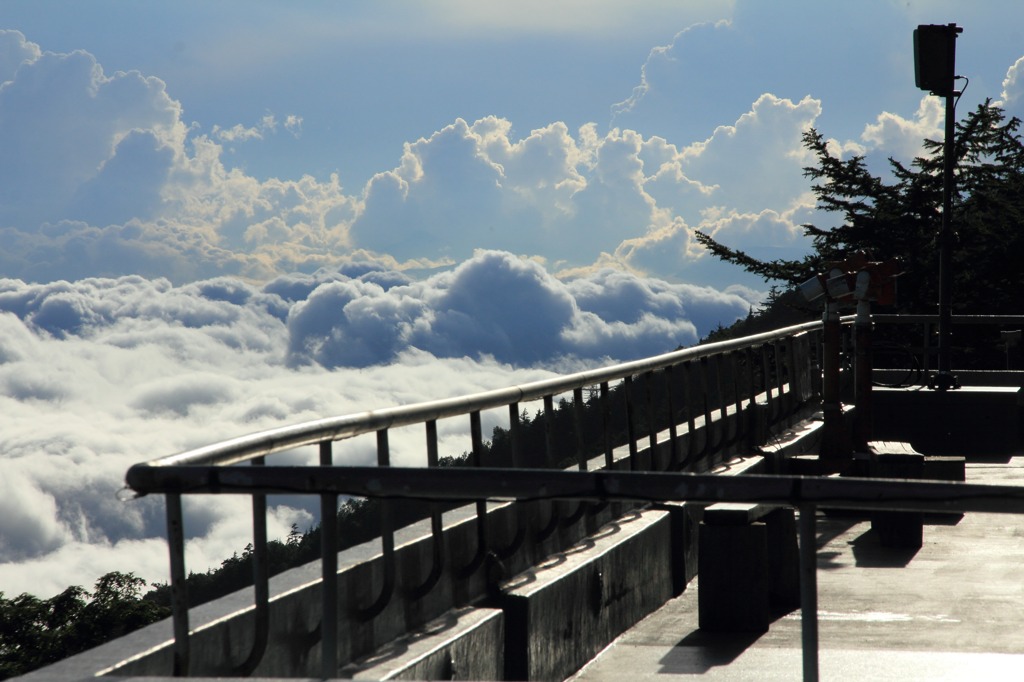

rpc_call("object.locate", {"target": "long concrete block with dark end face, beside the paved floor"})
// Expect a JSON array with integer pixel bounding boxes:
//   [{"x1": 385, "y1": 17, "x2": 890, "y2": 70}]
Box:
[{"x1": 500, "y1": 511, "x2": 672, "y2": 680}]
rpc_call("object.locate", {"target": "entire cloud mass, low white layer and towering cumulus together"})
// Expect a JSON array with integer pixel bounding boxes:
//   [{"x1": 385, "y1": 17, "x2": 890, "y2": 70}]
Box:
[{"x1": 0, "y1": 19, "x2": 1020, "y2": 596}]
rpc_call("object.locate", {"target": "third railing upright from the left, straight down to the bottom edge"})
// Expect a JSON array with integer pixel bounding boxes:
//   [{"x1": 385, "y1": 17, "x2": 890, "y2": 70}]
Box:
[{"x1": 319, "y1": 440, "x2": 338, "y2": 680}]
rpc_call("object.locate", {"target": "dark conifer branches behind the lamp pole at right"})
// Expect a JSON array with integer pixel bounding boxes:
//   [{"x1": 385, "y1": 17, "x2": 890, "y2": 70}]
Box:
[{"x1": 696, "y1": 101, "x2": 1024, "y2": 313}]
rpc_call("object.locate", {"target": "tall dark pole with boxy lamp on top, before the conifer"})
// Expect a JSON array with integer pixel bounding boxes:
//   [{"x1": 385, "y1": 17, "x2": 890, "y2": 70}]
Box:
[{"x1": 913, "y1": 24, "x2": 964, "y2": 391}]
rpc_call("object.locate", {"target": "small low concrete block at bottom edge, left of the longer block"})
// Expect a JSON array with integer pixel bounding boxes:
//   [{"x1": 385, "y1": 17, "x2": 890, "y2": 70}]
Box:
[{"x1": 341, "y1": 608, "x2": 505, "y2": 680}]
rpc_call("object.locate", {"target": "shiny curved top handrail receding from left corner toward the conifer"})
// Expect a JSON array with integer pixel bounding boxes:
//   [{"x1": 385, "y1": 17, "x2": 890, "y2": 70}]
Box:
[{"x1": 126, "y1": 322, "x2": 821, "y2": 483}]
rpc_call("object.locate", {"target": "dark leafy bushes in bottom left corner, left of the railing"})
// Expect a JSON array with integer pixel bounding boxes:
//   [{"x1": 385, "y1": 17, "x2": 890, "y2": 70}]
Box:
[{"x1": 0, "y1": 571, "x2": 169, "y2": 679}]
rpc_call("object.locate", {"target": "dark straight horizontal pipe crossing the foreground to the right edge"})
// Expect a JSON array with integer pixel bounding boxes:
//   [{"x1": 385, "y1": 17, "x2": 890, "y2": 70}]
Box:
[{"x1": 138, "y1": 466, "x2": 1024, "y2": 514}]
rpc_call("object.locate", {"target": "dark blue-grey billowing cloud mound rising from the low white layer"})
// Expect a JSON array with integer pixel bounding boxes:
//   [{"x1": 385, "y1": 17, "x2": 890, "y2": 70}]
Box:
[{"x1": 288, "y1": 251, "x2": 750, "y2": 367}]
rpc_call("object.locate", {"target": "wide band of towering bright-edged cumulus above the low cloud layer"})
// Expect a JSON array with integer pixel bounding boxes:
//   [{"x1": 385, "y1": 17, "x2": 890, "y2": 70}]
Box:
[{"x1": 0, "y1": 32, "x2": 815, "y2": 292}]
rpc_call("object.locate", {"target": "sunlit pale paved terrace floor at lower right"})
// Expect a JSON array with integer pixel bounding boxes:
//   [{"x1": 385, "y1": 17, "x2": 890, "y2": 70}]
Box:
[{"x1": 572, "y1": 458, "x2": 1024, "y2": 681}]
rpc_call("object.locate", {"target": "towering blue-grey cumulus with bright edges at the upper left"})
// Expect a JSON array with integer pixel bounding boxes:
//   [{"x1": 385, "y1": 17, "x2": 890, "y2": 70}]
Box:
[{"x1": 0, "y1": 31, "x2": 358, "y2": 282}]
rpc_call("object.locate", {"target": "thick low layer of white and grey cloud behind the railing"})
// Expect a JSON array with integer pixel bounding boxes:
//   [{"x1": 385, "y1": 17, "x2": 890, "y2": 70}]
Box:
[{"x1": 0, "y1": 251, "x2": 749, "y2": 596}]
